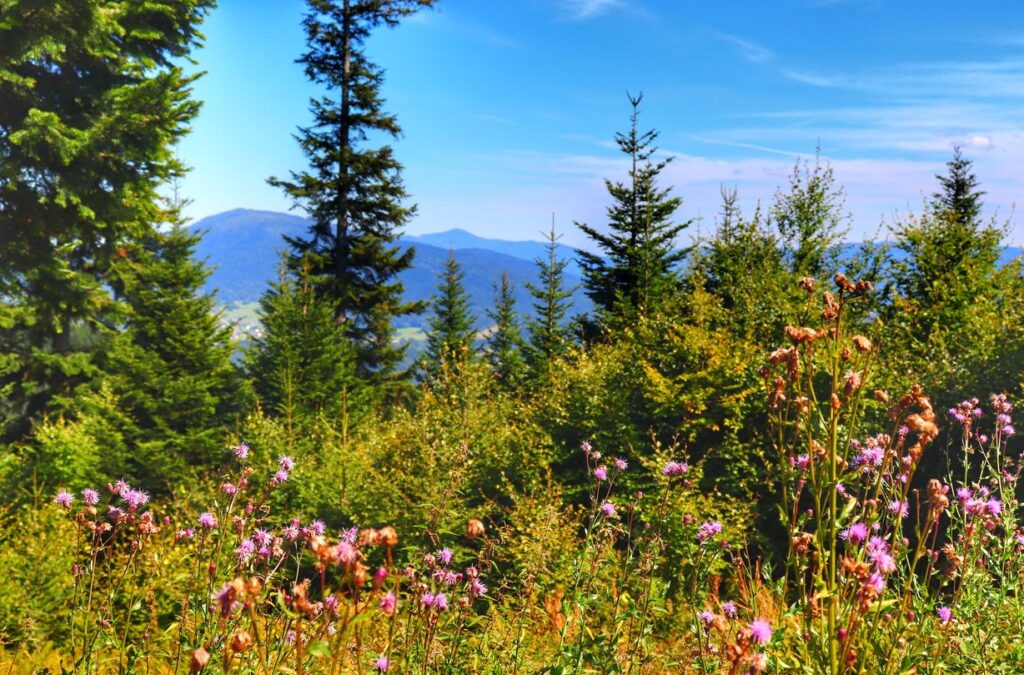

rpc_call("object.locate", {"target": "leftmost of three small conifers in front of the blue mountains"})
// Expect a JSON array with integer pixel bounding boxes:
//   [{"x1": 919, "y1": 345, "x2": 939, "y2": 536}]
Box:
[{"x1": 424, "y1": 251, "x2": 476, "y2": 374}]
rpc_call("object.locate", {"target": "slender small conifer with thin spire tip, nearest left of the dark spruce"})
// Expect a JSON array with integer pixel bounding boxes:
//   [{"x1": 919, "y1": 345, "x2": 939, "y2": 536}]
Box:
[{"x1": 526, "y1": 224, "x2": 574, "y2": 376}]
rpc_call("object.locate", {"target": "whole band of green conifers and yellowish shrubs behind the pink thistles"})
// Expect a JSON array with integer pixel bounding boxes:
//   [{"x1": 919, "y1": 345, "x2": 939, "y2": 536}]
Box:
[{"x1": 0, "y1": 0, "x2": 1024, "y2": 564}]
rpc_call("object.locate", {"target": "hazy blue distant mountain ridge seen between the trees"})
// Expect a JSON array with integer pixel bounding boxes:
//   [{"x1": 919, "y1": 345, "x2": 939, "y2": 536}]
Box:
[{"x1": 193, "y1": 209, "x2": 591, "y2": 330}]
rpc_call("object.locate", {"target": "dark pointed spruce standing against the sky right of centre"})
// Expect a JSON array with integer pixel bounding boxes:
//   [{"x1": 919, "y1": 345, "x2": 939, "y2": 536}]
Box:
[{"x1": 577, "y1": 94, "x2": 690, "y2": 321}]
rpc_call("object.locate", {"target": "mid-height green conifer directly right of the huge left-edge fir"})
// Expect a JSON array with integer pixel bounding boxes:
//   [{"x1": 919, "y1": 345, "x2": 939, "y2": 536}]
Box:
[{"x1": 101, "y1": 207, "x2": 243, "y2": 478}]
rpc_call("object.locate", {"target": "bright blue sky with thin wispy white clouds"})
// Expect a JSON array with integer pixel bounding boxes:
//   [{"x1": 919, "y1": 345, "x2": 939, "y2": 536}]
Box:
[{"x1": 179, "y1": 0, "x2": 1024, "y2": 245}]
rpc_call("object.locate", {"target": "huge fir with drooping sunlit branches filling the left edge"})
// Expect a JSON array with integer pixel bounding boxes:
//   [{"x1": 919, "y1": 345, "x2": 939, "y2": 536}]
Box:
[{"x1": 0, "y1": 0, "x2": 214, "y2": 439}]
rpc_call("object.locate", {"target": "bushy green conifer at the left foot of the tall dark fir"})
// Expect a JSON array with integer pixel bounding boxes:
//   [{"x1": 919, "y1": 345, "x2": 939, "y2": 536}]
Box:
[{"x1": 245, "y1": 262, "x2": 366, "y2": 431}]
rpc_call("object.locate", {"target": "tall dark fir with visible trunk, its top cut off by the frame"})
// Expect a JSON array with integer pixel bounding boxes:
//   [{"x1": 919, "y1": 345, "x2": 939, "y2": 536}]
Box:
[{"x1": 269, "y1": 0, "x2": 433, "y2": 391}]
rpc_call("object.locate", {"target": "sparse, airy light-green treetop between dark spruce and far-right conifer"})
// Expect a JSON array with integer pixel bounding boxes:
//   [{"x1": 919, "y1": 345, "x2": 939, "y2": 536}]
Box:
[{"x1": 771, "y1": 155, "x2": 850, "y2": 279}]
